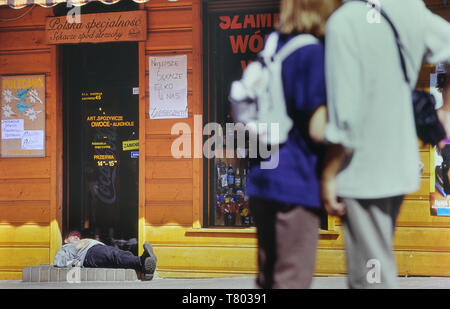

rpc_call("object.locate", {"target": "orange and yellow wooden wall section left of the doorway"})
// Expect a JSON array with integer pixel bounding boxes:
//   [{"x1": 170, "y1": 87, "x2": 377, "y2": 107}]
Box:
[{"x1": 0, "y1": 7, "x2": 59, "y2": 279}]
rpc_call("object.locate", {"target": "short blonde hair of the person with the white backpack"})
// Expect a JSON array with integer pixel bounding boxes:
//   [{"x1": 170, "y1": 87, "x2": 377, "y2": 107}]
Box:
[{"x1": 277, "y1": 0, "x2": 342, "y2": 37}]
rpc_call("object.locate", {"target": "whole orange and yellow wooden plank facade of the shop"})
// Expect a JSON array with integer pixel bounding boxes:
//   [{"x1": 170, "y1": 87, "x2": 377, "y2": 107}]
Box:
[{"x1": 0, "y1": 0, "x2": 450, "y2": 279}]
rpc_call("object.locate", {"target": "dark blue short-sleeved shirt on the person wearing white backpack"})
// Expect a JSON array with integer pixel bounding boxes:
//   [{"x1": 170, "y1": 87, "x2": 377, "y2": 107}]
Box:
[{"x1": 247, "y1": 35, "x2": 326, "y2": 208}]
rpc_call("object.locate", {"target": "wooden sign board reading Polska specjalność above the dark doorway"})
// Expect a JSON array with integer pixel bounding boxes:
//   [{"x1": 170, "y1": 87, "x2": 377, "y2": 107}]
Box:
[{"x1": 45, "y1": 11, "x2": 147, "y2": 44}]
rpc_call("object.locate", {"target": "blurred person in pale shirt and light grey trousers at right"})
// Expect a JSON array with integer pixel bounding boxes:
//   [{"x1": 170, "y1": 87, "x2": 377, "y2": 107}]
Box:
[{"x1": 321, "y1": 0, "x2": 450, "y2": 288}]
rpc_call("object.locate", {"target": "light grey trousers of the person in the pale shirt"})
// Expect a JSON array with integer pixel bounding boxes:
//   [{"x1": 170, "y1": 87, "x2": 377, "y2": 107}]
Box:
[{"x1": 342, "y1": 196, "x2": 403, "y2": 289}]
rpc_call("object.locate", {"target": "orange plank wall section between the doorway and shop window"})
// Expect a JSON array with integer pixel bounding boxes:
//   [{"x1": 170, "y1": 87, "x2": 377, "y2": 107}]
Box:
[{"x1": 141, "y1": 0, "x2": 199, "y2": 234}]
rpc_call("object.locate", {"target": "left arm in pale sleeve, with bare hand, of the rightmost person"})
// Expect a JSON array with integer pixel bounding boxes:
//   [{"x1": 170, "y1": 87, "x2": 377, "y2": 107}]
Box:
[{"x1": 321, "y1": 12, "x2": 362, "y2": 216}]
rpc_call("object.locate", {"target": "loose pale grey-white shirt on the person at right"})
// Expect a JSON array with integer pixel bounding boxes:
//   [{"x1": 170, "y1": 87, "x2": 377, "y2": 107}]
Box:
[{"x1": 325, "y1": 0, "x2": 450, "y2": 198}]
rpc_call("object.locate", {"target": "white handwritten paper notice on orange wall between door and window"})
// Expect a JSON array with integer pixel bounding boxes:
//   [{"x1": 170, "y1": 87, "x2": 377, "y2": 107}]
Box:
[{"x1": 149, "y1": 55, "x2": 188, "y2": 119}]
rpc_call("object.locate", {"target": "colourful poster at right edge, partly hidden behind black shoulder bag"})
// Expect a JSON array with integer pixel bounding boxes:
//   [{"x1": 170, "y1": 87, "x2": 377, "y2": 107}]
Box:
[{"x1": 430, "y1": 65, "x2": 450, "y2": 217}]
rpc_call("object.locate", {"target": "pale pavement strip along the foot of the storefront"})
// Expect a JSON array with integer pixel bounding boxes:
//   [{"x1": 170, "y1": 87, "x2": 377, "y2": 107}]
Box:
[{"x1": 0, "y1": 277, "x2": 450, "y2": 290}]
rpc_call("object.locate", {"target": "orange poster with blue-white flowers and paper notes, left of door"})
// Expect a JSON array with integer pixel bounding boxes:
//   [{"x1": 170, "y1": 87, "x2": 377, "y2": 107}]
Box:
[{"x1": 0, "y1": 75, "x2": 45, "y2": 158}]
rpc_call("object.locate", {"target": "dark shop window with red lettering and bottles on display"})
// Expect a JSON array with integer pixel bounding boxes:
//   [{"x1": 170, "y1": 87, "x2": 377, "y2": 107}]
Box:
[{"x1": 204, "y1": 1, "x2": 279, "y2": 227}]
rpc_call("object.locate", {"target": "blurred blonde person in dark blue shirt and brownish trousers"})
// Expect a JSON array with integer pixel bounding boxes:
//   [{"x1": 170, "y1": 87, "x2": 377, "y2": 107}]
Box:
[{"x1": 247, "y1": 0, "x2": 340, "y2": 289}]
